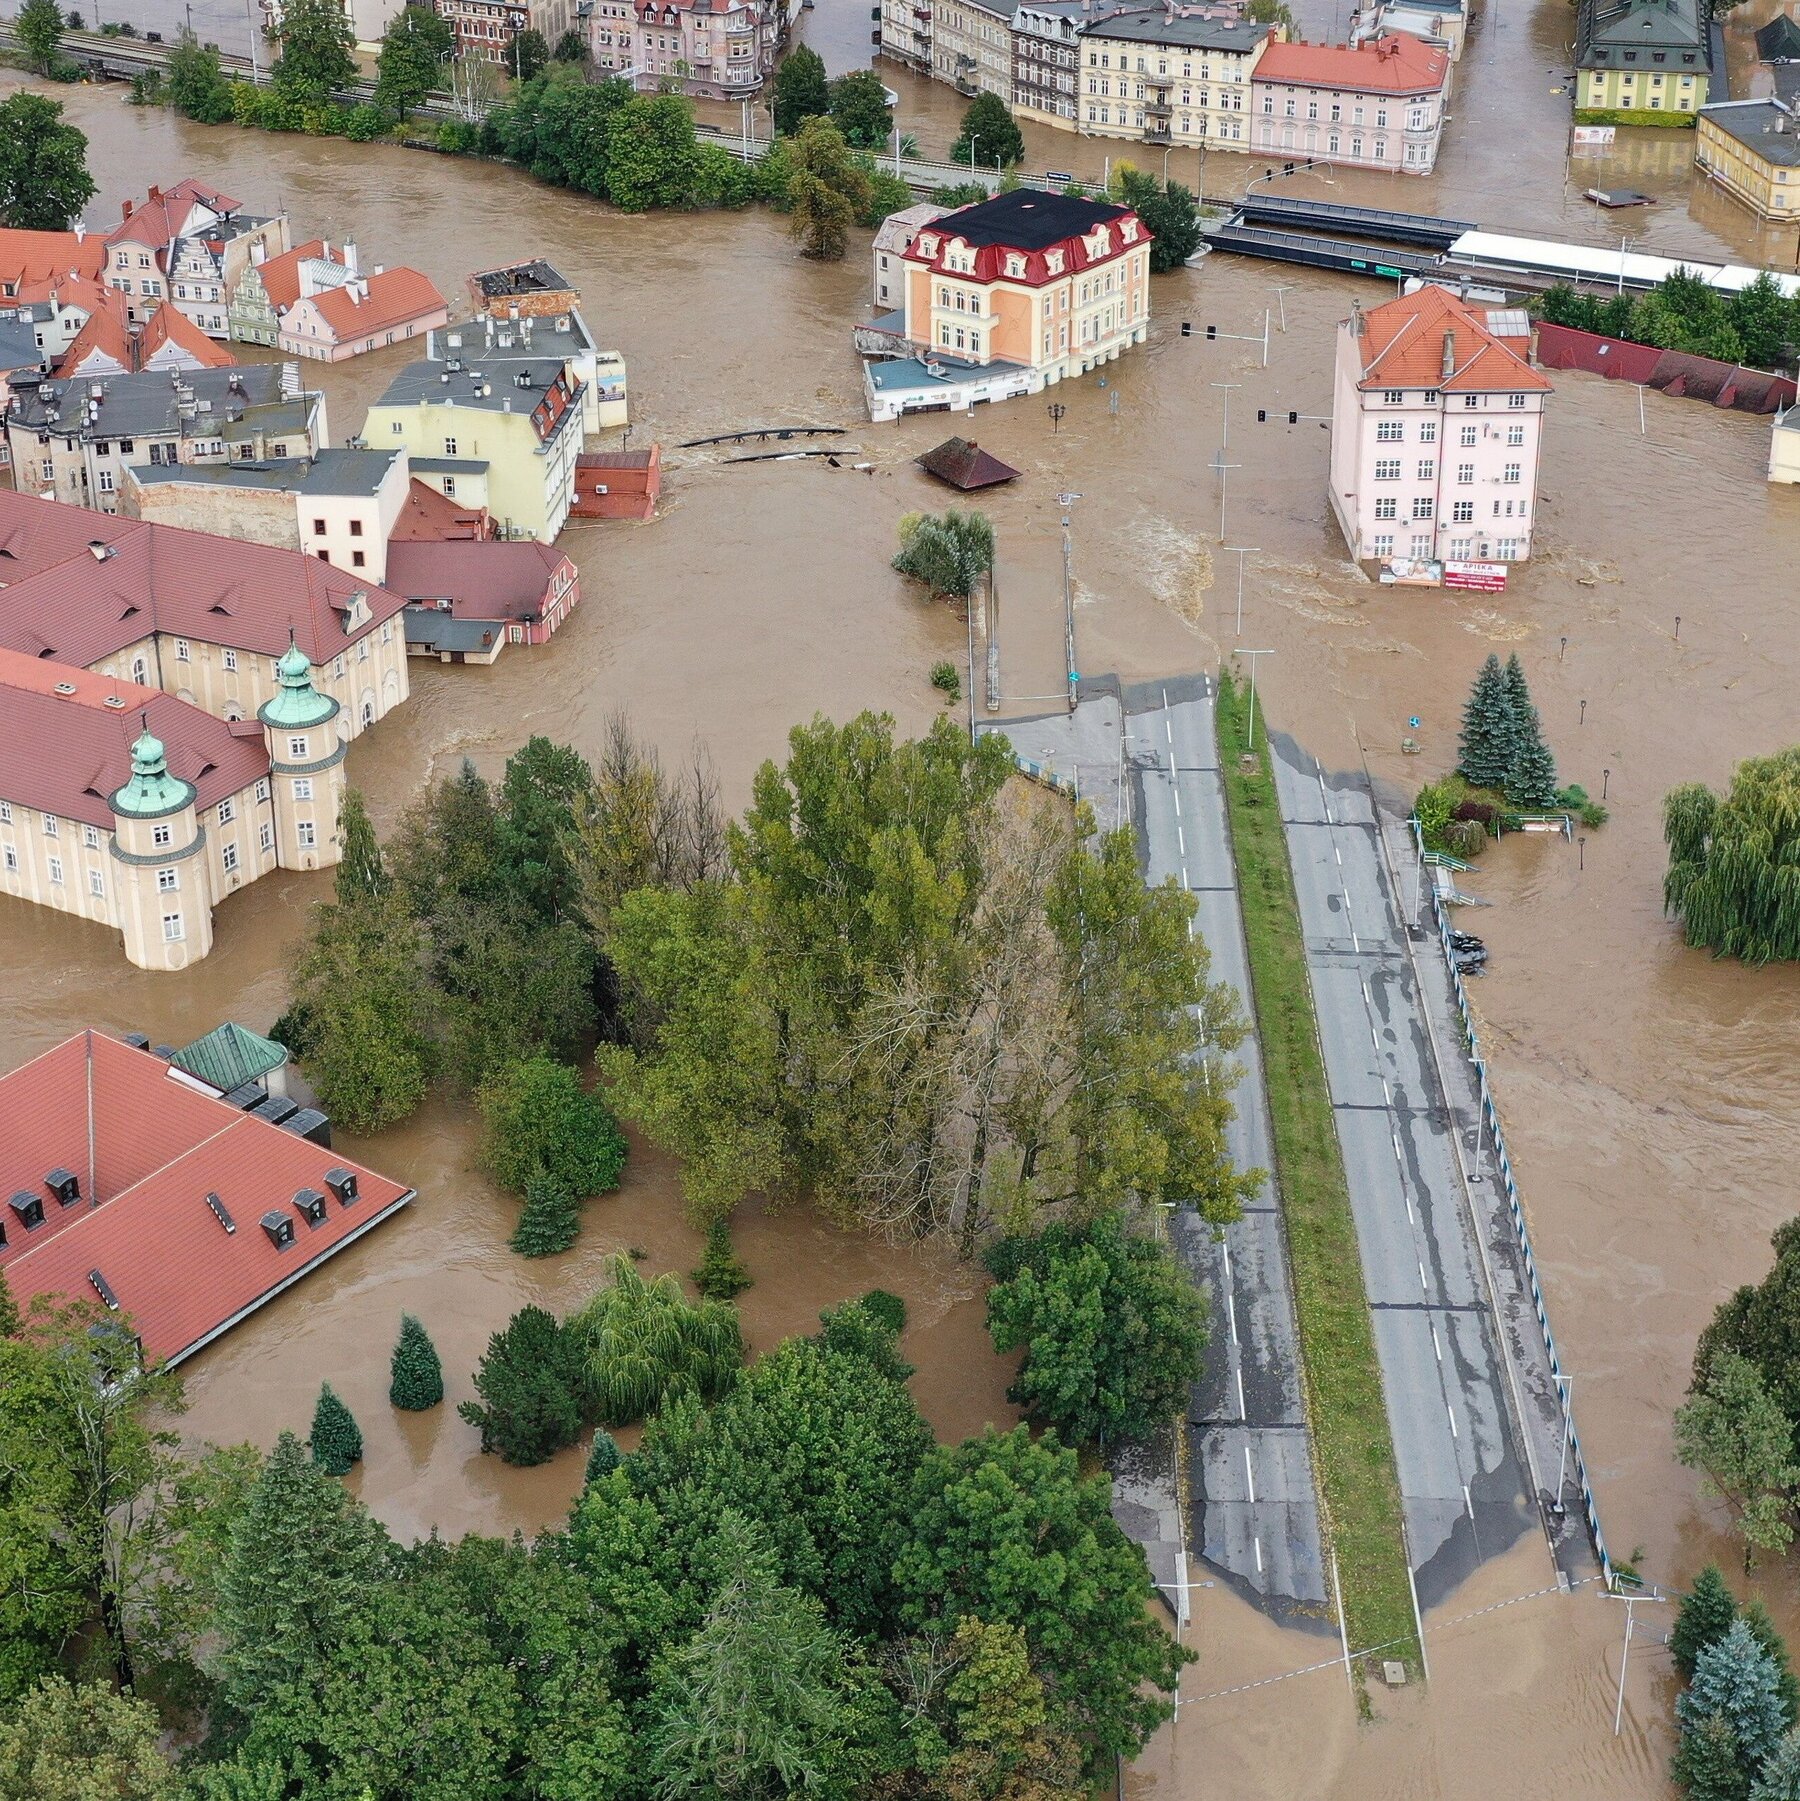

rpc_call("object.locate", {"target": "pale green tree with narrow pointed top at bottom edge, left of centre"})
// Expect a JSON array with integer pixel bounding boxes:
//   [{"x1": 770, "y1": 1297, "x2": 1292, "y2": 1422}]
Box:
[{"x1": 649, "y1": 1513, "x2": 882, "y2": 1801}]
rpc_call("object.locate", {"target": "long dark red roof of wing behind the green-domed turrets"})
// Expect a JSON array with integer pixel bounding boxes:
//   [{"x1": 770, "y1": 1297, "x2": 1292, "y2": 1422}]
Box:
[{"x1": 0, "y1": 490, "x2": 405, "y2": 668}]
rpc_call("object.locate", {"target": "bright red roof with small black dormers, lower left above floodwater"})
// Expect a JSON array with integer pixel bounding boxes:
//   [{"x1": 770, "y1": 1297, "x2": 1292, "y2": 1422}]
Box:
[{"x1": 0, "y1": 1032, "x2": 413, "y2": 1362}]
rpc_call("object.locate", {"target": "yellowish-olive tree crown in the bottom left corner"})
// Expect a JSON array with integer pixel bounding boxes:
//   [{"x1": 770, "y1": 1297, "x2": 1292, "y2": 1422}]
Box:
[{"x1": 0, "y1": 1677, "x2": 180, "y2": 1801}]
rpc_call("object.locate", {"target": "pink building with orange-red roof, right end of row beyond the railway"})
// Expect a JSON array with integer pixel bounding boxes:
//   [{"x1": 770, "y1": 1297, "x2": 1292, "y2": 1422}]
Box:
[{"x1": 1250, "y1": 31, "x2": 1450, "y2": 175}]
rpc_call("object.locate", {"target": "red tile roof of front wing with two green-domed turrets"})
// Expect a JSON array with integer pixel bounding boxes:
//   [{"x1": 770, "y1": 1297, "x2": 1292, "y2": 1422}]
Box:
[{"x1": 0, "y1": 650, "x2": 268, "y2": 832}]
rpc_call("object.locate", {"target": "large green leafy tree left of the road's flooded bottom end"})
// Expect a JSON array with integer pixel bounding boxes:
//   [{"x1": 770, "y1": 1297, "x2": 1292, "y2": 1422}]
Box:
[{"x1": 894, "y1": 1426, "x2": 1191, "y2": 1774}]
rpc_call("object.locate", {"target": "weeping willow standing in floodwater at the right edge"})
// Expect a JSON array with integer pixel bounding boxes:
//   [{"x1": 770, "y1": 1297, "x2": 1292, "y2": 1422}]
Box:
[{"x1": 1663, "y1": 746, "x2": 1800, "y2": 964}]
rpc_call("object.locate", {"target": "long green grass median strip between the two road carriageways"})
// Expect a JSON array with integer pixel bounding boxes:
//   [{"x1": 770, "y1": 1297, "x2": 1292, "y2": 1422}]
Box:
[{"x1": 1218, "y1": 675, "x2": 1418, "y2": 1668}]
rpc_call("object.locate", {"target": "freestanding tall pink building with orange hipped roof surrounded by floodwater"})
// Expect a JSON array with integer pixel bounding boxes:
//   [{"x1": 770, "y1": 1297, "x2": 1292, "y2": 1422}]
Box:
[{"x1": 1330, "y1": 288, "x2": 1551, "y2": 562}]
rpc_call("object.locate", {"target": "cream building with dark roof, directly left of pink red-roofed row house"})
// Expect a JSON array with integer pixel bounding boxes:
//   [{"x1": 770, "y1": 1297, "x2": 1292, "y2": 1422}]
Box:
[{"x1": 1081, "y1": 7, "x2": 1276, "y2": 149}]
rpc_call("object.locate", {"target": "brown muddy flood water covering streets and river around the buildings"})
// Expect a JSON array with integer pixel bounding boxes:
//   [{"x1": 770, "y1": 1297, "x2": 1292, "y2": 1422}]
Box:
[{"x1": 10, "y1": 0, "x2": 1800, "y2": 1801}]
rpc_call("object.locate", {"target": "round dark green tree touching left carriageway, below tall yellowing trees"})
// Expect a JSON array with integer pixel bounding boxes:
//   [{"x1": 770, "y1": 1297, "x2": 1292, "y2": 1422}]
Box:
[{"x1": 987, "y1": 1212, "x2": 1205, "y2": 1444}]
